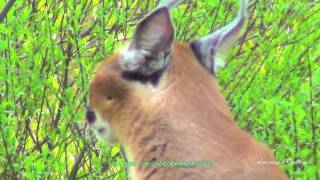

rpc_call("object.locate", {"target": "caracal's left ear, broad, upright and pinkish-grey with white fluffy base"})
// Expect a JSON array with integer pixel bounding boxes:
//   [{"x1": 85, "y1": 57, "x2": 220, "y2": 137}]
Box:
[{"x1": 122, "y1": 6, "x2": 174, "y2": 76}]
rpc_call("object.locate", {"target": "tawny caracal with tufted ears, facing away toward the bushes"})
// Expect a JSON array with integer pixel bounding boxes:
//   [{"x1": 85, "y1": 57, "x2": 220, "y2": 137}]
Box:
[{"x1": 87, "y1": 0, "x2": 287, "y2": 180}]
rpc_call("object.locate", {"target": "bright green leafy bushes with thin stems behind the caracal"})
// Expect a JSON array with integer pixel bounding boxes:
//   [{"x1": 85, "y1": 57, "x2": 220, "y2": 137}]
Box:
[{"x1": 0, "y1": 0, "x2": 320, "y2": 179}]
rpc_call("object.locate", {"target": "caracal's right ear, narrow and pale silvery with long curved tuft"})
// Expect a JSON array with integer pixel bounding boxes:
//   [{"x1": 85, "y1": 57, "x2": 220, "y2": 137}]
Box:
[{"x1": 191, "y1": 0, "x2": 248, "y2": 74}]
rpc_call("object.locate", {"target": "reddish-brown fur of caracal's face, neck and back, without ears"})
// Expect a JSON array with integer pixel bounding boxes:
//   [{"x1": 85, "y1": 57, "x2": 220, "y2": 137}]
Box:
[{"x1": 90, "y1": 44, "x2": 286, "y2": 180}]
